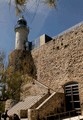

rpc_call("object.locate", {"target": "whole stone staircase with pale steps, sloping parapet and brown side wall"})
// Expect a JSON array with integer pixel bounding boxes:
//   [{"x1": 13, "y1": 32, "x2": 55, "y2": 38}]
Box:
[{"x1": 8, "y1": 92, "x2": 64, "y2": 120}]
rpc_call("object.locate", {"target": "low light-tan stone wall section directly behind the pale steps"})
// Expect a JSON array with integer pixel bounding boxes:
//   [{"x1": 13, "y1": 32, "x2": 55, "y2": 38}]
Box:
[{"x1": 20, "y1": 80, "x2": 48, "y2": 100}]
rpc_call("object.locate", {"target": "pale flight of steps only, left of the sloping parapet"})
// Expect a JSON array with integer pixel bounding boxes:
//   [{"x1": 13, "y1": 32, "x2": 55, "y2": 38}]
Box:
[{"x1": 8, "y1": 93, "x2": 49, "y2": 118}]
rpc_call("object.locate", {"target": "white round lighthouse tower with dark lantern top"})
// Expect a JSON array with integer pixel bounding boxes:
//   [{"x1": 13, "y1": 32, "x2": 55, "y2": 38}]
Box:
[{"x1": 15, "y1": 17, "x2": 29, "y2": 50}]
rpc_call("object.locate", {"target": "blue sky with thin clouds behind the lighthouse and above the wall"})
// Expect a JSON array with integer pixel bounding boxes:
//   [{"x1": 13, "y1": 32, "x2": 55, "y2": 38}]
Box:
[{"x1": 0, "y1": 0, "x2": 83, "y2": 61}]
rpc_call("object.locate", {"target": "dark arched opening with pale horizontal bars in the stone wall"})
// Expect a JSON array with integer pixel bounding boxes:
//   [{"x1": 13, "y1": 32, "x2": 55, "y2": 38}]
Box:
[{"x1": 64, "y1": 82, "x2": 80, "y2": 114}]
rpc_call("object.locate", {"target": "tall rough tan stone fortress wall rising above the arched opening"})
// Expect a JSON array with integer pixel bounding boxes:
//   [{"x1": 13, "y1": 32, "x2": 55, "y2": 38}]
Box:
[{"x1": 32, "y1": 24, "x2": 83, "y2": 114}]
